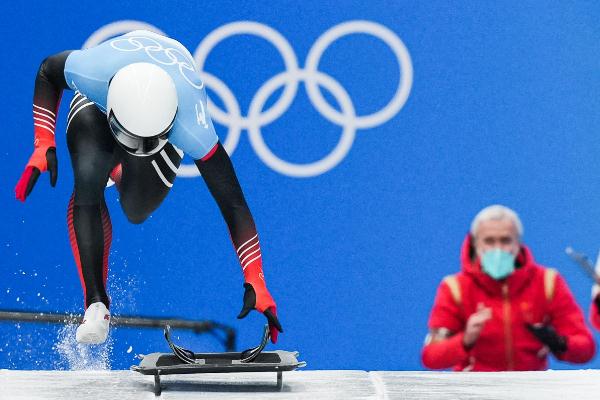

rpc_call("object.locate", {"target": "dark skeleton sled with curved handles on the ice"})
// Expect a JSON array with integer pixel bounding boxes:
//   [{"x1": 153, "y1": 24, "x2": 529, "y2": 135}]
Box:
[{"x1": 131, "y1": 326, "x2": 306, "y2": 396}]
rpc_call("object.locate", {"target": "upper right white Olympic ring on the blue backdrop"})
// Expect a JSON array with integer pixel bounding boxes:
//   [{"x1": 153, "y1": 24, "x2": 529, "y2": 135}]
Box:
[{"x1": 305, "y1": 20, "x2": 413, "y2": 129}]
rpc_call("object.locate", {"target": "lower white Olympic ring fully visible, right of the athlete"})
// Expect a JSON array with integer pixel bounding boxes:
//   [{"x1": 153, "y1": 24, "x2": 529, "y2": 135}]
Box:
[{"x1": 248, "y1": 70, "x2": 356, "y2": 178}]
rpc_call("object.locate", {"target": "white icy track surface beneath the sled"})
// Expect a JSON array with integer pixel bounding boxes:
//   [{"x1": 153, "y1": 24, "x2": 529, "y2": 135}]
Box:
[{"x1": 0, "y1": 370, "x2": 600, "y2": 400}]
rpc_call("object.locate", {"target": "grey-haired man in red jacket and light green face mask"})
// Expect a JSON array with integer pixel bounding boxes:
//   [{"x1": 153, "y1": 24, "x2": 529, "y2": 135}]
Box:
[{"x1": 422, "y1": 205, "x2": 595, "y2": 371}]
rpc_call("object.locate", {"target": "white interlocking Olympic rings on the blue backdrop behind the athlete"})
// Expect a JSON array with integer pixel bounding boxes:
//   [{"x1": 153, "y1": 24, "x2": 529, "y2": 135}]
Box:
[{"x1": 83, "y1": 20, "x2": 413, "y2": 177}]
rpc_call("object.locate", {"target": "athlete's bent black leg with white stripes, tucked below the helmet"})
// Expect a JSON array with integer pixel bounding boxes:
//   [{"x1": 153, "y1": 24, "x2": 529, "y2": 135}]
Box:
[{"x1": 118, "y1": 143, "x2": 182, "y2": 224}]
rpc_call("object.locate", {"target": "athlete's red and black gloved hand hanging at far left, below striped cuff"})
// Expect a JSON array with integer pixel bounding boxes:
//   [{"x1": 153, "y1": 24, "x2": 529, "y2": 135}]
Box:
[{"x1": 15, "y1": 147, "x2": 58, "y2": 201}]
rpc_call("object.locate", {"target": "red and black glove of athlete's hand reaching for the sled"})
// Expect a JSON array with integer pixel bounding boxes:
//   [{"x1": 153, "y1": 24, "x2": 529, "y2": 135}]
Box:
[{"x1": 238, "y1": 262, "x2": 283, "y2": 343}]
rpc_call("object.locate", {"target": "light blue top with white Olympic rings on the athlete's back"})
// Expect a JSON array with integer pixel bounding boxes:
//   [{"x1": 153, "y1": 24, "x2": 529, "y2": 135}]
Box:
[{"x1": 65, "y1": 30, "x2": 219, "y2": 160}]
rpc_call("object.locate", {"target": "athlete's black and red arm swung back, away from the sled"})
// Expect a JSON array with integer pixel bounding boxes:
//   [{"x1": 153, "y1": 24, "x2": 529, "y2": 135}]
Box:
[{"x1": 15, "y1": 51, "x2": 71, "y2": 201}]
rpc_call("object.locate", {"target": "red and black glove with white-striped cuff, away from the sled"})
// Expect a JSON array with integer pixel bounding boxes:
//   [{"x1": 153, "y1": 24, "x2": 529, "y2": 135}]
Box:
[{"x1": 15, "y1": 105, "x2": 58, "y2": 201}]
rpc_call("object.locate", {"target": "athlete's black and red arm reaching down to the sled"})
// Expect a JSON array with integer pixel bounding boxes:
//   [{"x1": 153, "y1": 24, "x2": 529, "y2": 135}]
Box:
[{"x1": 195, "y1": 143, "x2": 283, "y2": 343}]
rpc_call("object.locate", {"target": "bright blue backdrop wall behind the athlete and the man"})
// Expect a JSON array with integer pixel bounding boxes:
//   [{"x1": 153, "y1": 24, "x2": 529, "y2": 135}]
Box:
[{"x1": 0, "y1": 0, "x2": 600, "y2": 370}]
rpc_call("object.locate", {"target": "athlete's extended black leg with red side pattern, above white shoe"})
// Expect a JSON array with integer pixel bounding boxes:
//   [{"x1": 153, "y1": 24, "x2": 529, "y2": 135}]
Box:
[{"x1": 67, "y1": 95, "x2": 116, "y2": 308}]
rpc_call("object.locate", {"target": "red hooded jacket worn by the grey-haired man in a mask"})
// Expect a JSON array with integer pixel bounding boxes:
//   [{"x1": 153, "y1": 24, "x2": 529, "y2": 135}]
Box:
[{"x1": 422, "y1": 236, "x2": 595, "y2": 371}]
